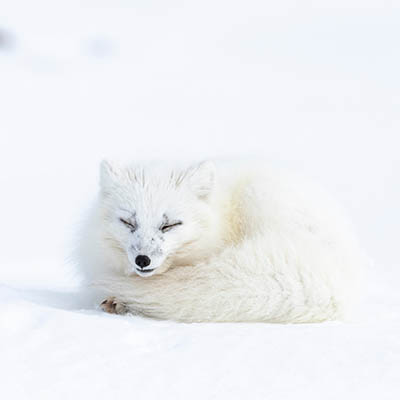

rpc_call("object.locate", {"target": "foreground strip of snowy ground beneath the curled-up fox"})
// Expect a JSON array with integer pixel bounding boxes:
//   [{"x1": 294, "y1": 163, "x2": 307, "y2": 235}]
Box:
[{"x1": 0, "y1": 272, "x2": 400, "y2": 399}]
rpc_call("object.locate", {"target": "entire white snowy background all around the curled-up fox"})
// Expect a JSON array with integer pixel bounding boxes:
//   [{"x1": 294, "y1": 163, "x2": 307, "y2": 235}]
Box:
[{"x1": 0, "y1": 0, "x2": 400, "y2": 400}]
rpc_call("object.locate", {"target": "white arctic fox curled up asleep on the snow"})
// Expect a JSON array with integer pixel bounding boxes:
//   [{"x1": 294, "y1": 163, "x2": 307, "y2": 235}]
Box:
[{"x1": 78, "y1": 161, "x2": 365, "y2": 323}]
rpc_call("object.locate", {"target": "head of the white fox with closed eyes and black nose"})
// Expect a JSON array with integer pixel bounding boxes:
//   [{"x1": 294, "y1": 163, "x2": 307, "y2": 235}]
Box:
[{"x1": 100, "y1": 161, "x2": 219, "y2": 277}]
